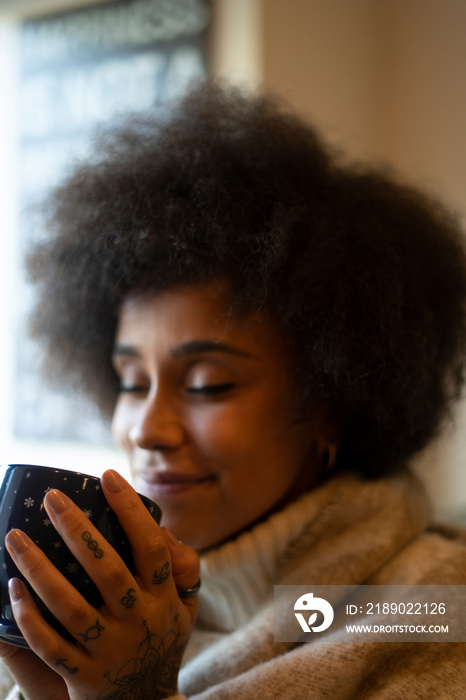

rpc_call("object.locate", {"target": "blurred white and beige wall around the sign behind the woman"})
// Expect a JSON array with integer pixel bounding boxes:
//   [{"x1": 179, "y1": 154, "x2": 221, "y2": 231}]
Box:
[{"x1": 0, "y1": 0, "x2": 466, "y2": 518}]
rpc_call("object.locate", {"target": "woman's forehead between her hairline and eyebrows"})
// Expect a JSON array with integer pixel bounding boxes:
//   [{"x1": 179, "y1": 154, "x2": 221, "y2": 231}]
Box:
[{"x1": 116, "y1": 282, "x2": 287, "y2": 353}]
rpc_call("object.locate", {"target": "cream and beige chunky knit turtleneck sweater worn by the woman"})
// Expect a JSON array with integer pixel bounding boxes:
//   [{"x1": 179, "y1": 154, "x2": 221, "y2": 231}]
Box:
[{"x1": 3, "y1": 472, "x2": 466, "y2": 700}]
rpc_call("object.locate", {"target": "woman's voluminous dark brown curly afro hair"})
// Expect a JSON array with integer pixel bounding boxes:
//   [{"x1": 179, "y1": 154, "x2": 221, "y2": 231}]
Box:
[{"x1": 29, "y1": 83, "x2": 466, "y2": 476}]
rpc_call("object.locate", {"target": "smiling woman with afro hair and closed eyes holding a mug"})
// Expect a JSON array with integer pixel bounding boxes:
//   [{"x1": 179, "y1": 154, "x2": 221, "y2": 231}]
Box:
[{"x1": 1, "y1": 80, "x2": 466, "y2": 700}]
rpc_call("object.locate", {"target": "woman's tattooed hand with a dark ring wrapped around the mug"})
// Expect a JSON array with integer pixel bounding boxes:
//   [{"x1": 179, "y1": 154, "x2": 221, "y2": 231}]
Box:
[{"x1": 0, "y1": 471, "x2": 199, "y2": 700}]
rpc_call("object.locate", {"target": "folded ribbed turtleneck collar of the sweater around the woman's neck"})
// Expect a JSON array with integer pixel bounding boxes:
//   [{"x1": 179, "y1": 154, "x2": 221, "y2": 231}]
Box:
[{"x1": 197, "y1": 471, "x2": 430, "y2": 634}]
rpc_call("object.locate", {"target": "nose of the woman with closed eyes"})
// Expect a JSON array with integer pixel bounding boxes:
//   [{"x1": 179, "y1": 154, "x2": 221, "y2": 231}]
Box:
[{"x1": 128, "y1": 391, "x2": 186, "y2": 450}]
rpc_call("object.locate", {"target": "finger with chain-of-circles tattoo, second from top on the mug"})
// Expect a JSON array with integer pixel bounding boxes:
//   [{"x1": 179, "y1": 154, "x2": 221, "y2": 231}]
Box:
[{"x1": 44, "y1": 490, "x2": 139, "y2": 617}]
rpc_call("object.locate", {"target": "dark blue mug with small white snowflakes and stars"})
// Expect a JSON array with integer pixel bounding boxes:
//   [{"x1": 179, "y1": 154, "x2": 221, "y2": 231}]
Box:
[{"x1": 0, "y1": 464, "x2": 161, "y2": 647}]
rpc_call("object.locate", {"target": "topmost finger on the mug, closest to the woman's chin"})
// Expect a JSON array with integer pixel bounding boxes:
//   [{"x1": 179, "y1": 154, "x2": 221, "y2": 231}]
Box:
[{"x1": 101, "y1": 469, "x2": 175, "y2": 596}]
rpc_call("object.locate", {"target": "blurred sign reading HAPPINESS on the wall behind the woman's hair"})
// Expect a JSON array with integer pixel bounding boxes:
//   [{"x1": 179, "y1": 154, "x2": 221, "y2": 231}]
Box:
[{"x1": 14, "y1": 0, "x2": 209, "y2": 442}]
